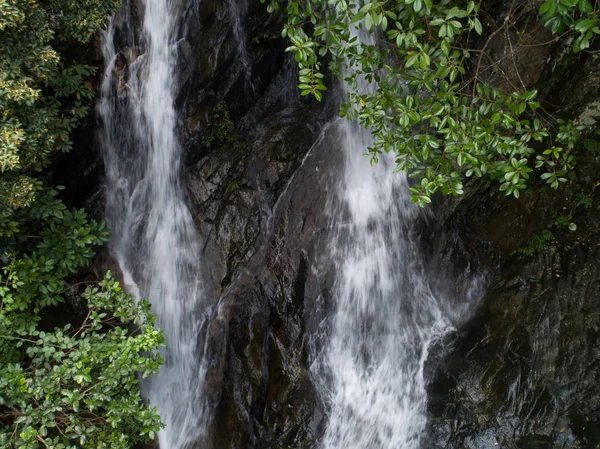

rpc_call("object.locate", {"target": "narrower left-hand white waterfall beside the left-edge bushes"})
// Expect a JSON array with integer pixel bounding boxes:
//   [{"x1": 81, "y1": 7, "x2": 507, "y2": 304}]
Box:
[{"x1": 100, "y1": 0, "x2": 205, "y2": 449}]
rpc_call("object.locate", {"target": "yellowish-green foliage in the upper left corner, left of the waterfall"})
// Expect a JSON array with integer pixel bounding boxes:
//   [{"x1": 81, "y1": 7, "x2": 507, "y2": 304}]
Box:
[{"x1": 0, "y1": 0, "x2": 116, "y2": 237}]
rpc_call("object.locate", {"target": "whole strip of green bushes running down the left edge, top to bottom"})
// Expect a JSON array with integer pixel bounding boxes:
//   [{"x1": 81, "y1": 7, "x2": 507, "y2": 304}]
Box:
[{"x1": 0, "y1": 0, "x2": 163, "y2": 449}]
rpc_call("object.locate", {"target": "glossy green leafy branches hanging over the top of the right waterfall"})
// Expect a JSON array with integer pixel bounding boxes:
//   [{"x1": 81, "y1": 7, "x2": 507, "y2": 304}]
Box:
[{"x1": 261, "y1": 0, "x2": 598, "y2": 205}]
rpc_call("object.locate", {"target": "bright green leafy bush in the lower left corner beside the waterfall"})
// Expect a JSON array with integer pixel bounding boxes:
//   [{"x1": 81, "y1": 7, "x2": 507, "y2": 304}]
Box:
[{"x1": 0, "y1": 270, "x2": 163, "y2": 449}]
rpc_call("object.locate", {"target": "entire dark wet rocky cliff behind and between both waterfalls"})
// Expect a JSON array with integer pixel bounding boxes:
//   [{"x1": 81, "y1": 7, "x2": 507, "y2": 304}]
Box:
[{"x1": 57, "y1": 0, "x2": 600, "y2": 449}]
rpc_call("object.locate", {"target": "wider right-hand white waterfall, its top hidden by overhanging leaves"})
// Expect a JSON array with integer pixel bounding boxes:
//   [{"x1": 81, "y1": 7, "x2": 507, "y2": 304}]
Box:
[{"x1": 313, "y1": 15, "x2": 451, "y2": 449}]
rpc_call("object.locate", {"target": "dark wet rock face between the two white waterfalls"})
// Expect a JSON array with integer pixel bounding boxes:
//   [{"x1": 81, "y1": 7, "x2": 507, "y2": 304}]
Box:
[{"x1": 158, "y1": 1, "x2": 339, "y2": 449}]
